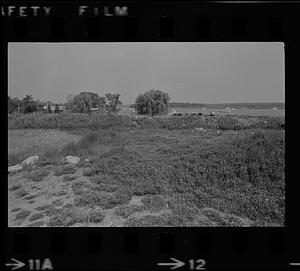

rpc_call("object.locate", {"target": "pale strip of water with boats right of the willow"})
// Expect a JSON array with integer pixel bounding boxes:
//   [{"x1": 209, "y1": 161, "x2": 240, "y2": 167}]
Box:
[{"x1": 170, "y1": 107, "x2": 285, "y2": 117}]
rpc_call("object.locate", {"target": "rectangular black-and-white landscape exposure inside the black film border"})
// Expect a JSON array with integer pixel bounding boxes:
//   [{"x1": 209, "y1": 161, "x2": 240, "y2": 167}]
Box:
[{"x1": 7, "y1": 42, "x2": 285, "y2": 227}]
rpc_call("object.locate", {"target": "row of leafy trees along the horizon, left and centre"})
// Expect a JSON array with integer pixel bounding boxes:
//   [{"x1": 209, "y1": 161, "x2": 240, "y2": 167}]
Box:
[{"x1": 8, "y1": 90, "x2": 170, "y2": 116}]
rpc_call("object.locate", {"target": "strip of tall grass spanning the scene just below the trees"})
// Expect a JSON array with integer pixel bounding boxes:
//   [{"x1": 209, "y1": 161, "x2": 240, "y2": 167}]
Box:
[{"x1": 8, "y1": 113, "x2": 285, "y2": 130}]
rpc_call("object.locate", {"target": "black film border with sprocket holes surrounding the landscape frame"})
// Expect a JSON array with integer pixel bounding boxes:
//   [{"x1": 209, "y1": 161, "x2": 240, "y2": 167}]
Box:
[{"x1": 1, "y1": 1, "x2": 300, "y2": 270}]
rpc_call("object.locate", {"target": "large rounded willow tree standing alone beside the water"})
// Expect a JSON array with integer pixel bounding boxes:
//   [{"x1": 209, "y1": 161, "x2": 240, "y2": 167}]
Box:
[{"x1": 135, "y1": 90, "x2": 170, "y2": 116}]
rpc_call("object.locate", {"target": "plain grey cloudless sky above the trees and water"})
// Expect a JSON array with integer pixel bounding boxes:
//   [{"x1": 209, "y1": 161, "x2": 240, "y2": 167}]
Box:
[{"x1": 8, "y1": 42, "x2": 284, "y2": 104}]
